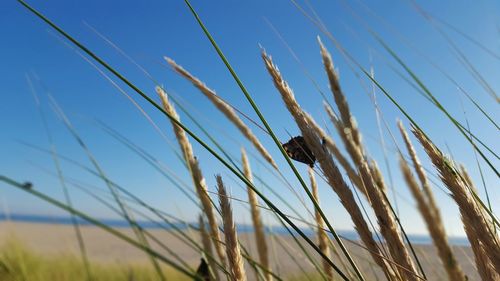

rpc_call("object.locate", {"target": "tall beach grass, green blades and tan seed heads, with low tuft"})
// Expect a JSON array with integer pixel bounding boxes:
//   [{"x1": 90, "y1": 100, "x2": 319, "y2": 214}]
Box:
[{"x1": 0, "y1": 0, "x2": 500, "y2": 281}]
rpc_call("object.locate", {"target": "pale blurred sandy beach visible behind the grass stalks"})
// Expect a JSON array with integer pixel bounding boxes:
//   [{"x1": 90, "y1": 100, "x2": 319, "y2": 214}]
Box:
[{"x1": 0, "y1": 222, "x2": 479, "y2": 280}]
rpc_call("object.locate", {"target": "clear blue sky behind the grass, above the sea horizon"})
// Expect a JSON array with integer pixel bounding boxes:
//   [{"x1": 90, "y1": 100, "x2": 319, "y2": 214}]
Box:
[{"x1": 0, "y1": 0, "x2": 500, "y2": 235}]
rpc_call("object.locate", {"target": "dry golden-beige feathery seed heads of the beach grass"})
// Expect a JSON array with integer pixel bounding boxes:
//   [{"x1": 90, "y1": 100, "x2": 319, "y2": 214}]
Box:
[{"x1": 77, "y1": 41, "x2": 500, "y2": 281}]
